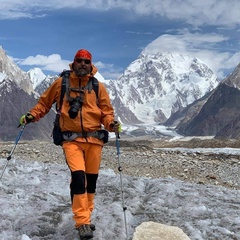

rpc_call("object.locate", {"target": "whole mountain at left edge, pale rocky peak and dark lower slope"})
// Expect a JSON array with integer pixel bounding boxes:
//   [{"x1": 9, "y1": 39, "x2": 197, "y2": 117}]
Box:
[{"x1": 0, "y1": 48, "x2": 55, "y2": 141}]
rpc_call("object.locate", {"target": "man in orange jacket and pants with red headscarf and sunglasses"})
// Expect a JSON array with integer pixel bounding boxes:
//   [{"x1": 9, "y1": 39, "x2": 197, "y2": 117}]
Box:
[{"x1": 20, "y1": 49, "x2": 120, "y2": 239}]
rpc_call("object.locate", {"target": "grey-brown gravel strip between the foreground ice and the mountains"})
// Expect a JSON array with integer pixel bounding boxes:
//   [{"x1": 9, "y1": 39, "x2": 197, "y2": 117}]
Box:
[{"x1": 0, "y1": 138, "x2": 240, "y2": 189}]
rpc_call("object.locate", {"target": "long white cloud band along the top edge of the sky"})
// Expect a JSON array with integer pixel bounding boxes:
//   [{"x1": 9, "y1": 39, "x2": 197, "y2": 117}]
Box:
[{"x1": 0, "y1": 0, "x2": 240, "y2": 26}]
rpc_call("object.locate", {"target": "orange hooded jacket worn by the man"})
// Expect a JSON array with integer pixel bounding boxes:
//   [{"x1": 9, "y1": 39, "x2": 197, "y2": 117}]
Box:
[{"x1": 30, "y1": 65, "x2": 114, "y2": 143}]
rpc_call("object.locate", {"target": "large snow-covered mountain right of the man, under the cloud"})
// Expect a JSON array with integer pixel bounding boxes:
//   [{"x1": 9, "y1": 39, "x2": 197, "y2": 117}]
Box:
[{"x1": 108, "y1": 50, "x2": 218, "y2": 123}]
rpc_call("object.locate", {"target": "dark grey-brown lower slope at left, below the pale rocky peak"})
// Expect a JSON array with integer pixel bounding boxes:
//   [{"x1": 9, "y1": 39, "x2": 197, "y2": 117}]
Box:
[{"x1": 0, "y1": 78, "x2": 55, "y2": 141}]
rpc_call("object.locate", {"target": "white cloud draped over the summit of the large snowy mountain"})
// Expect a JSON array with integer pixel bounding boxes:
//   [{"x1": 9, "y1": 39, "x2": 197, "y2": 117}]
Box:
[{"x1": 142, "y1": 33, "x2": 240, "y2": 78}]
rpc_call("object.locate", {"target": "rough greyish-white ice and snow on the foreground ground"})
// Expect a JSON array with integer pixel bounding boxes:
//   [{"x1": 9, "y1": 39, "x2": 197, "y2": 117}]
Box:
[{"x1": 0, "y1": 145, "x2": 240, "y2": 240}]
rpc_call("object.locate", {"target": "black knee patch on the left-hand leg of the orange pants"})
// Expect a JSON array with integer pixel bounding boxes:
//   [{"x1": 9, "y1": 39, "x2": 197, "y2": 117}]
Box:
[{"x1": 71, "y1": 171, "x2": 86, "y2": 195}]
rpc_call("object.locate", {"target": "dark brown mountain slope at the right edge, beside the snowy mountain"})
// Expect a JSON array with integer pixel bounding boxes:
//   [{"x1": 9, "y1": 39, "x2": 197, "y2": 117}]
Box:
[{"x1": 174, "y1": 64, "x2": 240, "y2": 138}]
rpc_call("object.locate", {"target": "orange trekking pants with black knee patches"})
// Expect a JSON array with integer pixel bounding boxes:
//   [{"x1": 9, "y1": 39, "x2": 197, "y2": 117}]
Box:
[{"x1": 63, "y1": 141, "x2": 102, "y2": 228}]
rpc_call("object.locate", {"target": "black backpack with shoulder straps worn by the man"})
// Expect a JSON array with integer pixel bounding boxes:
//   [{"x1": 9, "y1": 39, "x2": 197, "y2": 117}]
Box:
[{"x1": 52, "y1": 70, "x2": 98, "y2": 146}]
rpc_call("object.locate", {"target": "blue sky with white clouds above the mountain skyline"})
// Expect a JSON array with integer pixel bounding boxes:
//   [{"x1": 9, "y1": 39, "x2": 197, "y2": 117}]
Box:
[{"x1": 0, "y1": 0, "x2": 240, "y2": 79}]
